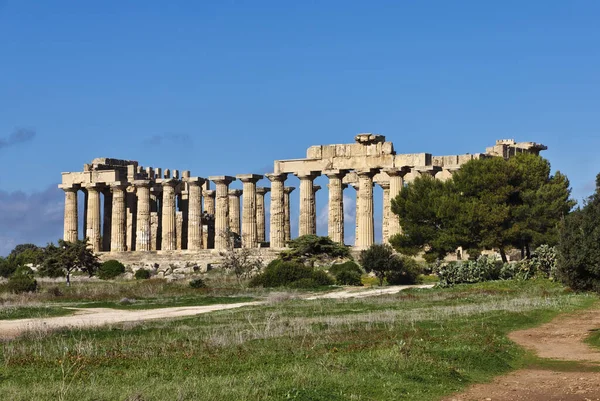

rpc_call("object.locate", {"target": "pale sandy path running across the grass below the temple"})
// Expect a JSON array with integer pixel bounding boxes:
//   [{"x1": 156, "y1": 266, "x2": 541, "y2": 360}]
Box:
[{"x1": 0, "y1": 285, "x2": 432, "y2": 340}]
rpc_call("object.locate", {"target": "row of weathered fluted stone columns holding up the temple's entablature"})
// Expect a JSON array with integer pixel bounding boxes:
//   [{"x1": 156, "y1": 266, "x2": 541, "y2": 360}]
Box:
[{"x1": 61, "y1": 168, "x2": 418, "y2": 252}]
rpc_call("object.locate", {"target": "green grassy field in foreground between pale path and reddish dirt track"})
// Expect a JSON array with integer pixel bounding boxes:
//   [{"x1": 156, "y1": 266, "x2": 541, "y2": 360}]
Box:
[{"x1": 0, "y1": 280, "x2": 597, "y2": 401}]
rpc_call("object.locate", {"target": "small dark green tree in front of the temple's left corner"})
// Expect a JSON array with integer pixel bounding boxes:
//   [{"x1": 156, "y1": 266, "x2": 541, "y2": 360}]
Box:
[{"x1": 41, "y1": 240, "x2": 100, "y2": 286}]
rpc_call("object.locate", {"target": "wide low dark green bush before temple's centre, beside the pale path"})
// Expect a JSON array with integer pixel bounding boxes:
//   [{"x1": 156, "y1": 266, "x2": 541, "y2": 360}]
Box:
[{"x1": 249, "y1": 259, "x2": 334, "y2": 288}]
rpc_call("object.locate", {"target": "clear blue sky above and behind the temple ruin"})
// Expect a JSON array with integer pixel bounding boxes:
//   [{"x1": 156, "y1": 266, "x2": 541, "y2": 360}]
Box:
[{"x1": 0, "y1": 0, "x2": 600, "y2": 255}]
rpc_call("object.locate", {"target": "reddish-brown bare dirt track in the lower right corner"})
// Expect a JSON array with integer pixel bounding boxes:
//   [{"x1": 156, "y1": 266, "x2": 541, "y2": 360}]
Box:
[{"x1": 444, "y1": 309, "x2": 600, "y2": 401}]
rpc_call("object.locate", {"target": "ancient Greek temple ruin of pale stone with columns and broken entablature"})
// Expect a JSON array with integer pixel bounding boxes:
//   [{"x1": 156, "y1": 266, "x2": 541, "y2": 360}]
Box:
[{"x1": 59, "y1": 134, "x2": 546, "y2": 253}]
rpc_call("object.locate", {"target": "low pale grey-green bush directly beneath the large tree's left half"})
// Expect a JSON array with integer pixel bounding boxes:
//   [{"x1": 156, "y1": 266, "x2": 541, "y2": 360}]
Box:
[{"x1": 437, "y1": 255, "x2": 503, "y2": 287}]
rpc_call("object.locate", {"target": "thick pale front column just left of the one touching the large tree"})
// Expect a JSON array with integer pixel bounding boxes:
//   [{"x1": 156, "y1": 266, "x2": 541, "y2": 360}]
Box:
[{"x1": 356, "y1": 169, "x2": 377, "y2": 249}]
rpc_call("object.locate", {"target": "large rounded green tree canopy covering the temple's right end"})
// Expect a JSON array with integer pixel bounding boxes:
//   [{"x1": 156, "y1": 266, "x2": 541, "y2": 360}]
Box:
[{"x1": 390, "y1": 153, "x2": 575, "y2": 261}]
